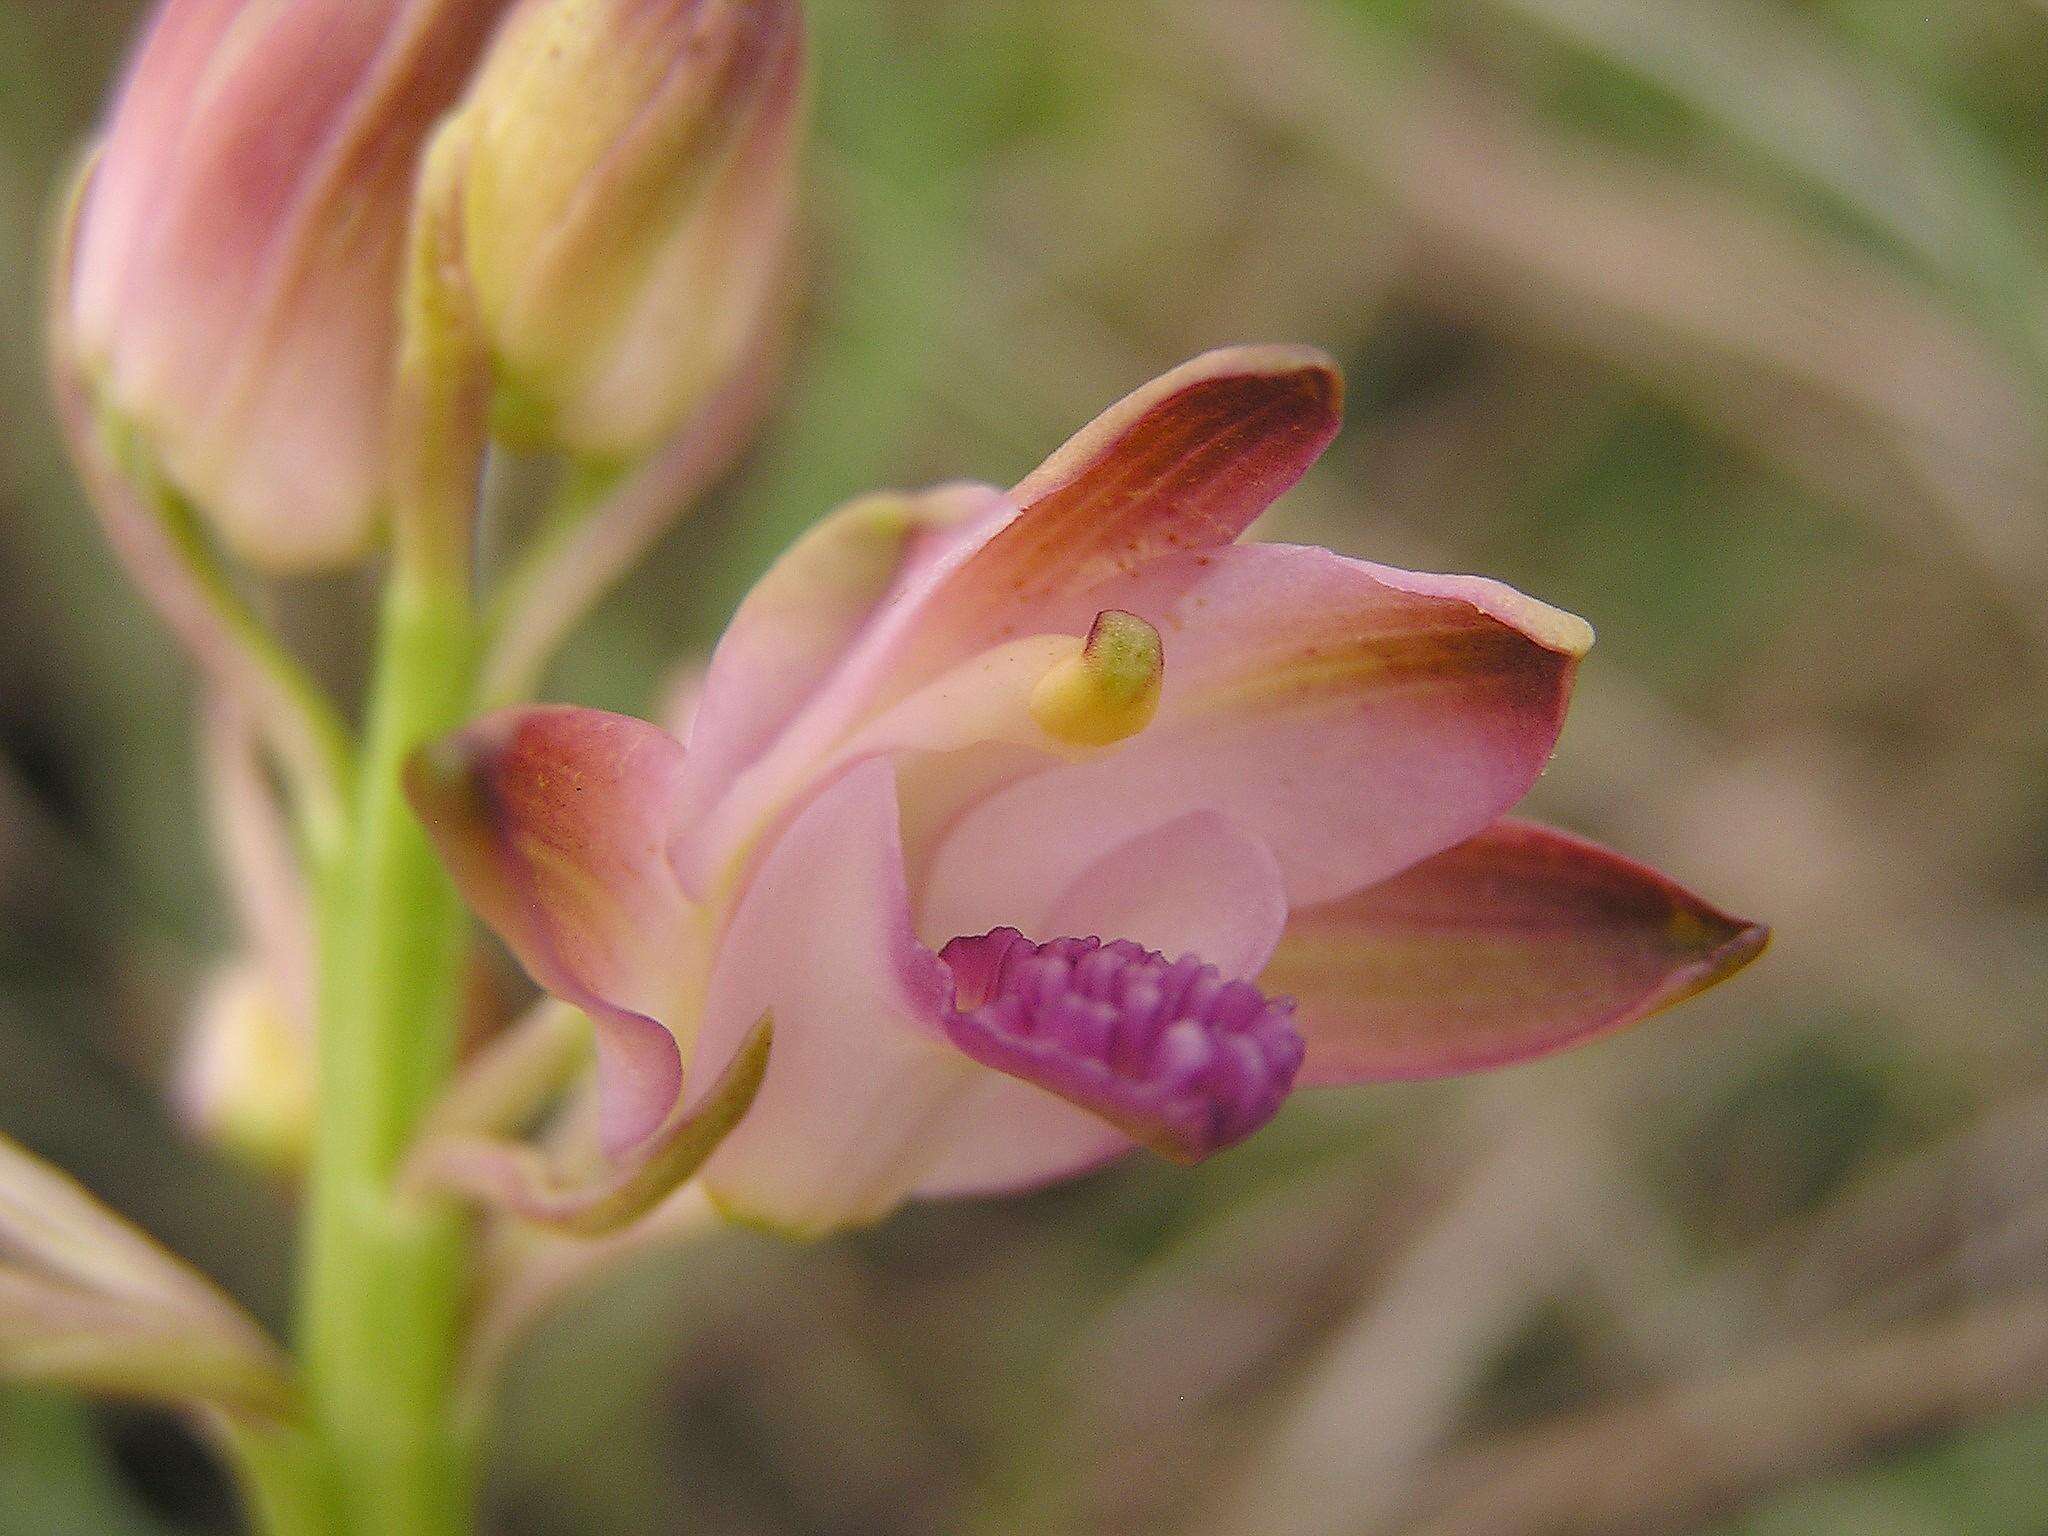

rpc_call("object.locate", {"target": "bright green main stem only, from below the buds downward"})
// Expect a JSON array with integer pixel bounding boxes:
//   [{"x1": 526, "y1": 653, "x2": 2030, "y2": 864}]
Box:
[{"x1": 303, "y1": 553, "x2": 475, "y2": 1536}]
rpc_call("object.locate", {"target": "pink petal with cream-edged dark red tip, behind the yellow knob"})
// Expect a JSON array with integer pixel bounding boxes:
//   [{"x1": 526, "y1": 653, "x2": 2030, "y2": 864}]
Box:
[{"x1": 926, "y1": 545, "x2": 1591, "y2": 934}]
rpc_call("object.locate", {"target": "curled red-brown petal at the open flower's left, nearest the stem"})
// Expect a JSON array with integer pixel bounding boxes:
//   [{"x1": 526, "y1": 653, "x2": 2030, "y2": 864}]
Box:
[{"x1": 408, "y1": 707, "x2": 700, "y2": 1151}]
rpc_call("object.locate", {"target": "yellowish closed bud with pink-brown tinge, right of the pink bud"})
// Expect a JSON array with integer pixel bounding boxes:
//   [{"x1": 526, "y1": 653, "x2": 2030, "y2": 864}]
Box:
[{"x1": 461, "y1": 0, "x2": 803, "y2": 459}]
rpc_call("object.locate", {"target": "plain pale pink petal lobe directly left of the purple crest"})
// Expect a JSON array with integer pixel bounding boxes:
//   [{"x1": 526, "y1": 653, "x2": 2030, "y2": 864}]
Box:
[{"x1": 688, "y1": 760, "x2": 983, "y2": 1233}]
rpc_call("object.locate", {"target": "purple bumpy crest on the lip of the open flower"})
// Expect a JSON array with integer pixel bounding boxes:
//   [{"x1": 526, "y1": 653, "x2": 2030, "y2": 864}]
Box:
[{"x1": 940, "y1": 928, "x2": 1305, "y2": 1163}]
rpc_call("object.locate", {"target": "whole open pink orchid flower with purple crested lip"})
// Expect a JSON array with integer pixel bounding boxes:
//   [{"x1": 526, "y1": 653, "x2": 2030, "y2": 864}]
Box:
[{"x1": 414, "y1": 346, "x2": 1765, "y2": 1233}]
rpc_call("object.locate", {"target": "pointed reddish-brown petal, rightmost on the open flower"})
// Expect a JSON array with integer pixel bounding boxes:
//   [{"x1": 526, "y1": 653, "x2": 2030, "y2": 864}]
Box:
[{"x1": 1260, "y1": 821, "x2": 1767, "y2": 1083}]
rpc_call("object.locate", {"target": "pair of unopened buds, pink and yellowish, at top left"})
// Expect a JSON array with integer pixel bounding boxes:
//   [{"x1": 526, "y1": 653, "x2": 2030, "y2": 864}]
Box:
[{"x1": 55, "y1": 0, "x2": 803, "y2": 571}]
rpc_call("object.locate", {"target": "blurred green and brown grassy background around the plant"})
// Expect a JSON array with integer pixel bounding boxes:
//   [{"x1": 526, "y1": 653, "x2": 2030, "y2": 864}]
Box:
[{"x1": 0, "y1": 0, "x2": 2048, "y2": 1536}]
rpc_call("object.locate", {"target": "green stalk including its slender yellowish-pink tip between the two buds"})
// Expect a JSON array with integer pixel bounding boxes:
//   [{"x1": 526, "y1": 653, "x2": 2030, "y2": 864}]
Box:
[{"x1": 301, "y1": 117, "x2": 489, "y2": 1536}]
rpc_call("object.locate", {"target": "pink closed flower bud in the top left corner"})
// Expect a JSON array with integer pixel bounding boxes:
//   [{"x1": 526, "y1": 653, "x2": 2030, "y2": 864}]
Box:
[{"x1": 57, "y1": 0, "x2": 510, "y2": 569}]
